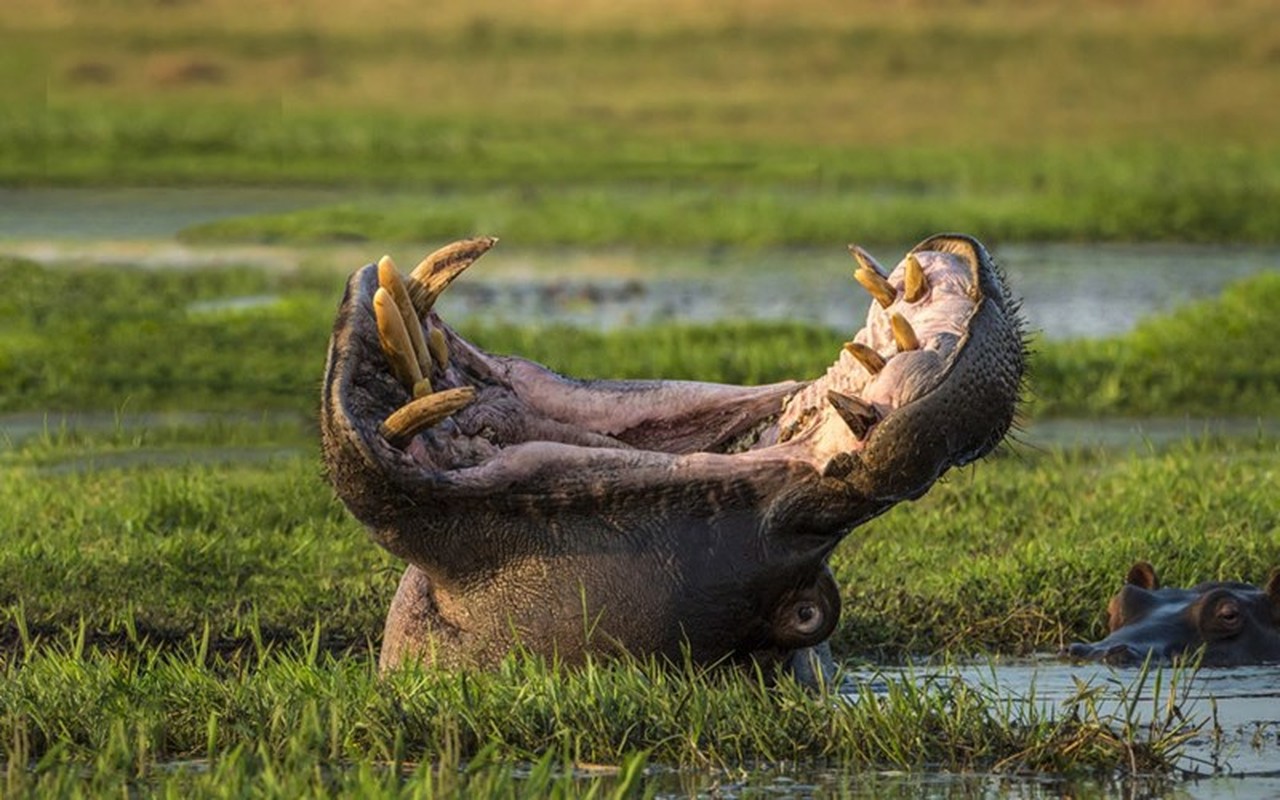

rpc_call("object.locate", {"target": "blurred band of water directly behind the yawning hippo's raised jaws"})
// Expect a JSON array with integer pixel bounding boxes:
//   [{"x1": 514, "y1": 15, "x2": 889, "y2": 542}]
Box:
[{"x1": 0, "y1": 187, "x2": 1280, "y2": 339}]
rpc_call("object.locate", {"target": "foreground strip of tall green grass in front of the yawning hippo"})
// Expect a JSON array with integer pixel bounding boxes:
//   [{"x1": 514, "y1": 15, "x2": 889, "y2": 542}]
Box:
[{"x1": 0, "y1": 629, "x2": 1193, "y2": 796}]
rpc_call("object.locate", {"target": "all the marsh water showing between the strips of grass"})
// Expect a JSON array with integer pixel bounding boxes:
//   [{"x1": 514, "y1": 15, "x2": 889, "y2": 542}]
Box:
[{"x1": 0, "y1": 189, "x2": 1280, "y2": 797}]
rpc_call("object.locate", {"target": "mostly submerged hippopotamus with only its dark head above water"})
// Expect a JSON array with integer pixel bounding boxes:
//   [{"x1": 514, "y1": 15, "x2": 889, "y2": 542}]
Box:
[{"x1": 1066, "y1": 561, "x2": 1280, "y2": 667}]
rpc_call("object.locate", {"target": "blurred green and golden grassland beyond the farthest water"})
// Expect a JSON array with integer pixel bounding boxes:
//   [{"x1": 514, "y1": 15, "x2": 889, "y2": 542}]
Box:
[{"x1": 0, "y1": 0, "x2": 1280, "y2": 246}]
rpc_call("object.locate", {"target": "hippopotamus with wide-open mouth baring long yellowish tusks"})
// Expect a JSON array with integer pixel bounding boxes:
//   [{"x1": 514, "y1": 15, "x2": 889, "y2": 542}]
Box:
[{"x1": 320, "y1": 234, "x2": 1027, "y2": 680}]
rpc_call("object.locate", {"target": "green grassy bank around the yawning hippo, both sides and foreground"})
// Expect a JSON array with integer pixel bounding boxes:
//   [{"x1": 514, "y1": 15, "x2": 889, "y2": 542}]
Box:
[{"x1": 0, "y1": 428, "x2": 1244, "y2": 794}]
